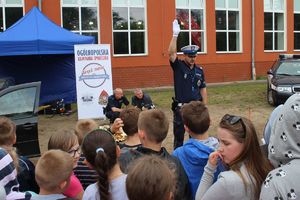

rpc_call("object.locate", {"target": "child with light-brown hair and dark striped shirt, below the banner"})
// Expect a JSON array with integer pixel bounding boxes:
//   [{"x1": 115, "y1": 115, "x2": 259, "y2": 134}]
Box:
[{"x1": 74, "y1": 119, "x2": 99, "y2": 190}]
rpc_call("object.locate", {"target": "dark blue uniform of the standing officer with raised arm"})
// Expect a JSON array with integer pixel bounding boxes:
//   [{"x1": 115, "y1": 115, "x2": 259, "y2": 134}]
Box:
[{"x1": 170, "y1": 58, "x2": 206, "y2": 149}]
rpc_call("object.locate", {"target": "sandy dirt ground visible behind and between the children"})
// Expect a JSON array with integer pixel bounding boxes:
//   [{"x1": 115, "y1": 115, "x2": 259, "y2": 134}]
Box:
[{"x1": 39, "y1": 106, "x2": 273, "y2": 153}]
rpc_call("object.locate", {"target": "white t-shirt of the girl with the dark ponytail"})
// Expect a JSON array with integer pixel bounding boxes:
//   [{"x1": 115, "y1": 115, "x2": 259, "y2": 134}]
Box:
[{"x1": 82, "y1": 174, "x2": 128, "y2": 200}]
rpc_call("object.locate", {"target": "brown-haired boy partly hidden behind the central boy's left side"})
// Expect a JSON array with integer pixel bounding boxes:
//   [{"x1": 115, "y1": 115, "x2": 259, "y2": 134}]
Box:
[{"x1": 119, "y1": 107, "x2": 141, "y2": 152}]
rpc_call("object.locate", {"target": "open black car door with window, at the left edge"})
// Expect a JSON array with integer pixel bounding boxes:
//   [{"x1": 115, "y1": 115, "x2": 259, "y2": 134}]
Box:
[{"x1": 0, "y1": 82, "x2": 41, "y2": 157}]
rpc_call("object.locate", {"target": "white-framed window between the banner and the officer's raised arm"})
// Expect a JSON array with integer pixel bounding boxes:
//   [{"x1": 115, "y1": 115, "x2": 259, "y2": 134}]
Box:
[{"x1": 112, "y1": 0, "x2": 147, "y2": 55}]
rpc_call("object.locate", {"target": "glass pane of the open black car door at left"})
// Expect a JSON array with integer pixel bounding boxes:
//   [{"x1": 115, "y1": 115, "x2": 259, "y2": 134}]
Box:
[{"x1": 0, "y1": 87, "x2": 36, "y2": 118}]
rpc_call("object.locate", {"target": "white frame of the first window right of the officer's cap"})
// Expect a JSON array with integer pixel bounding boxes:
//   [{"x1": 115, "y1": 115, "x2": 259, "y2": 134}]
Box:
[{"x1": 215, "y1": 0, "x2": 243, "y2": 54}]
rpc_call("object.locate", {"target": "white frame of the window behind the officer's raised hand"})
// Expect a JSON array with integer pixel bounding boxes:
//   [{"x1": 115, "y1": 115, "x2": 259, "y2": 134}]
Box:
[{"x1": 175, "y1": 0, "x2": 207, "y2": 55}]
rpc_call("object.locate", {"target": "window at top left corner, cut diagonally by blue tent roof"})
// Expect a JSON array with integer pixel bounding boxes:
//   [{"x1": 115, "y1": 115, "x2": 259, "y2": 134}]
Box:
[{"x1": 0, "y1": 0, "x2": 24, "y2": 32}]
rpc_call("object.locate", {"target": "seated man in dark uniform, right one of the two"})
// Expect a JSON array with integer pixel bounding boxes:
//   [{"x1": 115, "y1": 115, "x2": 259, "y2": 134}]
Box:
[{"x1": 131, "y1": 88, "x2": 154, "y2": 110}]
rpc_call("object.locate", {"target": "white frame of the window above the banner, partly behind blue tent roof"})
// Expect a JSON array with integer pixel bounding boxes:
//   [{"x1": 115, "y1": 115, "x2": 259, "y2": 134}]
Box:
[{"x1": 60, "y1": 0, "x2": 101, "y2": 44}]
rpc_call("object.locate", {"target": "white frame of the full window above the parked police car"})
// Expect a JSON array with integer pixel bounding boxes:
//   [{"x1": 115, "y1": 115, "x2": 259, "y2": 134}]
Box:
[{"x1": 263, "y1": 0, "x2": 287, "y2": 53}]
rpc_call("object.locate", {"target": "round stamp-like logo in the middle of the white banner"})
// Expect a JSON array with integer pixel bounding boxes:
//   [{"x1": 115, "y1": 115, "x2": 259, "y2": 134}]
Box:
[{"x1": 79, "y1": 63, "x2": 109, "y2": 88}]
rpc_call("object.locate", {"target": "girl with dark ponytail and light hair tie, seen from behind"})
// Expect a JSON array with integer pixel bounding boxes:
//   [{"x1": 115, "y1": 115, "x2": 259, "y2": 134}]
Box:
[{"x1": 82, "y1": 129, "x2": 128, "y2": 200}]
